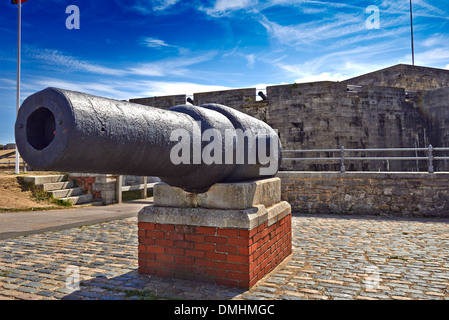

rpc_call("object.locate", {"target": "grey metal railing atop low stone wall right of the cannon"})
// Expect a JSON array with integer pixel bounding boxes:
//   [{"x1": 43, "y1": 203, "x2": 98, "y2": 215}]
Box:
[{"x1": 282, "y1": 145, "x2": 449, "y2": 173}]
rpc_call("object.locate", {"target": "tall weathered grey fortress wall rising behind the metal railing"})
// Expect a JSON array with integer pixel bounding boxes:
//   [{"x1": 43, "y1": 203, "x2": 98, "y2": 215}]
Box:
[{"x1": 130, "y1": 65, "x2": 449, "y2": 172}]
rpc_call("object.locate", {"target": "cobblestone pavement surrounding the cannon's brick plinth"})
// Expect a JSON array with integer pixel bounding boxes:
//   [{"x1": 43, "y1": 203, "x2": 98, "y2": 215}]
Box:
[{"x1": 0, "y1": 215, "x2": 449, "y2": 300}]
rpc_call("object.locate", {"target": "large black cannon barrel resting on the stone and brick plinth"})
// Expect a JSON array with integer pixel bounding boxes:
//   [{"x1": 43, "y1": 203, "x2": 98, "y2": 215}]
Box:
[{"x1": 15, "y1": 88, "x2": 281, "y2": 193}]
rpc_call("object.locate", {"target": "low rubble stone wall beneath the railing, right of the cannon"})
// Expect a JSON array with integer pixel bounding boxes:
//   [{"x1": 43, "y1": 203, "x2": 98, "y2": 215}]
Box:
[{"x1": 278, "y1": 171, "x2": 449, "y2": 218}]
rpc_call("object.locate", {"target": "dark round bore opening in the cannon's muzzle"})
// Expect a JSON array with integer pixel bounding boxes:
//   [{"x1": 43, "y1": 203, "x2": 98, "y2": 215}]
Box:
[{"x1": 26, "y1": 108, "x2": 56, "y2": 150}]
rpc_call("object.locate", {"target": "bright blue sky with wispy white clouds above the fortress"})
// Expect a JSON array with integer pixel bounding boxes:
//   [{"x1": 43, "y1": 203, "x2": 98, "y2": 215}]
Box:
[{"x1": 0, "y1": 0, "x2": 449, "y2": 144}]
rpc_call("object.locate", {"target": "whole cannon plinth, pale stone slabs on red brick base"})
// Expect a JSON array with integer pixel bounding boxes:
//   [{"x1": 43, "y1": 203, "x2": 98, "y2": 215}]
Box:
[{"x1": 139, "y1": 178, "x2": 292, "y2": 289}]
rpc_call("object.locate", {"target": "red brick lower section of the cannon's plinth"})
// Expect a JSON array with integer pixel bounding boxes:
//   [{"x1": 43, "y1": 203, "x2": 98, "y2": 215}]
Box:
[{"x1": 139, "y1": 214, "x2": 292, "y2": 289}]
